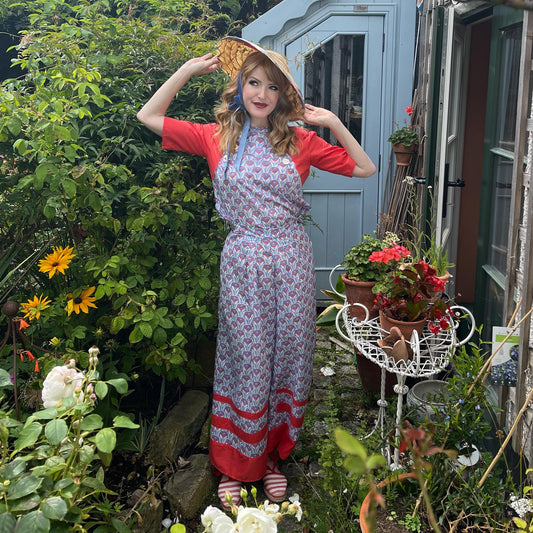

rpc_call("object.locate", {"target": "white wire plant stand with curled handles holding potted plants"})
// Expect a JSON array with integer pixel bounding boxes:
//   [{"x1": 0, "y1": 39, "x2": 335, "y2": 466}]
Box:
[{"x1": 335, "y1": 303, "x2": 476, "y2": 469}]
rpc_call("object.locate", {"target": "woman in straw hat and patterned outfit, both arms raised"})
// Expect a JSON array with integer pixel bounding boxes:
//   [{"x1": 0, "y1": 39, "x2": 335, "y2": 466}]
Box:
[{"x1": 137, "y1": 37, "x2": 375, "y2": 508}]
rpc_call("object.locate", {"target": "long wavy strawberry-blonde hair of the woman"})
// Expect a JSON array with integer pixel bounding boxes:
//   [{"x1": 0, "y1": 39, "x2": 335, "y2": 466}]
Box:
[{"x1": 215, "y1": 52, "x2": 303, "y2": 156}]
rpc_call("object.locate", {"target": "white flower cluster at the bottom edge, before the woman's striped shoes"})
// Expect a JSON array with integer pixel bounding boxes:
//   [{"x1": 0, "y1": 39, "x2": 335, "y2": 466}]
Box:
[{"x1": 201, "y1": 495, "x2": 302, "y2": 533}]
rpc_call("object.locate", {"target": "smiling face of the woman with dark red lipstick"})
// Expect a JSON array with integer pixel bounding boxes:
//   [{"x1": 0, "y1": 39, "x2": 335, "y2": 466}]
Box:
[{"x1": 242, "y1": 67, "x2": 279, "y2": 128}]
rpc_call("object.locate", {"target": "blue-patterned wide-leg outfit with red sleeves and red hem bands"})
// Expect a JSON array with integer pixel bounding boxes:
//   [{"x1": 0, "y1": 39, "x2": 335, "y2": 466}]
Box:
[{"x1": 163, "y1": 118, "x2": 355, "y2": 482}]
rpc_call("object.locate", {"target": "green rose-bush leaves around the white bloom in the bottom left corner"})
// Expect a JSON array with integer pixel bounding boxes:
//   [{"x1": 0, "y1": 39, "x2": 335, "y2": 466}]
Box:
[{"x1": 0, "y1": 350, "x2": 138, "y2": 533}]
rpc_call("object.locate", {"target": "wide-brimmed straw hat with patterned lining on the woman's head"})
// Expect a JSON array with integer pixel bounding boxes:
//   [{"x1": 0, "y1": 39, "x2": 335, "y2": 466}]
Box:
[{"x1": 218, "y1": 37, "x2": 304, "y2": 114}]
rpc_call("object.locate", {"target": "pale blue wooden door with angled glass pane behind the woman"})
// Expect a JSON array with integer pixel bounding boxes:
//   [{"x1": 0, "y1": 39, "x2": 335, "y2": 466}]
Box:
[{"x1": 286, "y1": 15, "x2": 384, "y2": 299}]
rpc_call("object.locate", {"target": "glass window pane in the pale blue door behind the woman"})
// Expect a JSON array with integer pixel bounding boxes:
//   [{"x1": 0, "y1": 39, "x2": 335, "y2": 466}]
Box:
[{"x1": 304, "y1": 35, "x2": 365, "y2": 144}]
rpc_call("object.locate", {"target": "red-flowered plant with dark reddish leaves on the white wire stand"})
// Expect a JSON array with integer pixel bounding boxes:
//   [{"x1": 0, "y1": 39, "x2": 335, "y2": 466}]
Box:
[{"x1": 370, "y1": 245, "x2": 451, "y2": 339}]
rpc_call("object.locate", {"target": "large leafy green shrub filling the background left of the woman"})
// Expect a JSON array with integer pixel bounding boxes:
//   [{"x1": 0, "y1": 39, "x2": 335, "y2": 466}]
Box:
[{"x1": 0, "y1": 0, "x2": 232, "y2": 381}]
